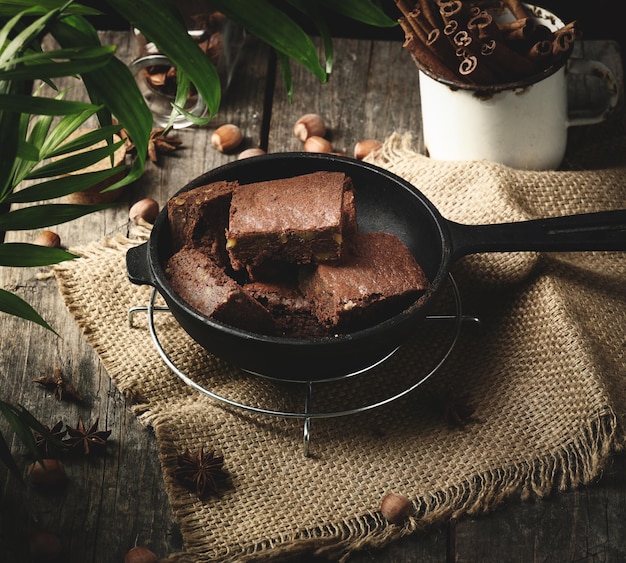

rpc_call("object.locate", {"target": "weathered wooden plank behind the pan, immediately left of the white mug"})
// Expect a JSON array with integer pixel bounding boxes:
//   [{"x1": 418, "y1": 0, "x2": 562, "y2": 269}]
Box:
[{"x1": 269, "y1": 39, "x2": 421, "y2": 156}]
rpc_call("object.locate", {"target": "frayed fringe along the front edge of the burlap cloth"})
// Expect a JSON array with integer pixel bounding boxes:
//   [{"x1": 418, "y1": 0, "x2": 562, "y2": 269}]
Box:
[{"x1": 155, "y1": 412, "x2": 617, "y2": 563}]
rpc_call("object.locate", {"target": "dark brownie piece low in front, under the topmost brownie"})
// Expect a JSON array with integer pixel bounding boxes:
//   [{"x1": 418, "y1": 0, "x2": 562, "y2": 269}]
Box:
[{"x1": 243, "y1": 282, "x2": 328, "y2": 338}]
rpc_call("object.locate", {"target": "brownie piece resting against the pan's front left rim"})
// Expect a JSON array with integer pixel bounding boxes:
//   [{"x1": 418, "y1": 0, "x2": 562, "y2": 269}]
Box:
[{"x1": 165, "y1": 247, "x2": 275, "y2": 334}]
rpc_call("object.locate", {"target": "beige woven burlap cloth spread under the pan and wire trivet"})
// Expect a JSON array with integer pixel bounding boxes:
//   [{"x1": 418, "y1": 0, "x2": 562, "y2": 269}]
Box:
[{"x1": 55, "y1": 130, "x2": 626, "y2": 562}]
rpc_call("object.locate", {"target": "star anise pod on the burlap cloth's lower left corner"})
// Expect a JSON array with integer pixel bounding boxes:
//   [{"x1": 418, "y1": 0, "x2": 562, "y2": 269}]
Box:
[{"x1": 173, "y1": 447, "x2": 227, "y2": 498}]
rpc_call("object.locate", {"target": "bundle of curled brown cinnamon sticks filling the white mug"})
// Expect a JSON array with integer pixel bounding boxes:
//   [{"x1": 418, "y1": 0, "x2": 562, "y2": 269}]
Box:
[{"x1": 395, "y1": 0, "x2": 578, "y2": 85}]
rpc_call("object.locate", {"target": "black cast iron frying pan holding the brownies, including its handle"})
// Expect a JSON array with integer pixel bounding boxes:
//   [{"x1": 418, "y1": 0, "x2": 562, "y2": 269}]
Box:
[{"x1": 126, "y1": 153, "x2": 626, "y2": 381}]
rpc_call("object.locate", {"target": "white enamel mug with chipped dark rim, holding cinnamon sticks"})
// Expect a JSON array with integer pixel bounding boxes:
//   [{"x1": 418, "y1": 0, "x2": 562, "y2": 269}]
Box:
[{"x1": 419, "y1": 5, "x2": 618, "y2": 170}]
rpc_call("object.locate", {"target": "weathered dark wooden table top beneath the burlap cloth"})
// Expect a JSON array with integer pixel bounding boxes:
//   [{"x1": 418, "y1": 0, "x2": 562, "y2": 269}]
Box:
[{"x1": 0, "y1": 32, "x2": 626, "y2": 563}]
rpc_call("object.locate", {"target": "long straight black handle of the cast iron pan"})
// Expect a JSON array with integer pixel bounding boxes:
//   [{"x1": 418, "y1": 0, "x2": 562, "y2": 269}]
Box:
[{"x1": 448, "y1": 209, "x2": 626, "y2": 259}]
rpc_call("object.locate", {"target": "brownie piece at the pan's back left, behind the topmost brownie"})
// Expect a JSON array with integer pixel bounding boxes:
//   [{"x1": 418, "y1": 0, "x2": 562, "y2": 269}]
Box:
[{"x1": 167, "y1": 181, "x2": 237, "y2": 265}]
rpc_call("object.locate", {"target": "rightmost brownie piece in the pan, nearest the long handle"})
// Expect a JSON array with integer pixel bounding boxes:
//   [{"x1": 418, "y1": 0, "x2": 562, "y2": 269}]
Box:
[{"x1": 300, "y1": 233, "x2": 428, "y2": 332}]
